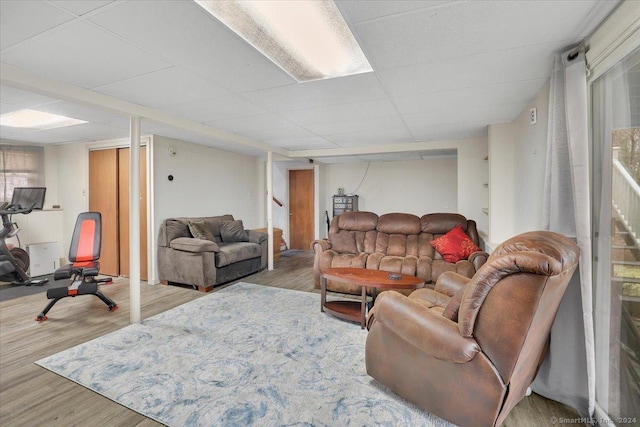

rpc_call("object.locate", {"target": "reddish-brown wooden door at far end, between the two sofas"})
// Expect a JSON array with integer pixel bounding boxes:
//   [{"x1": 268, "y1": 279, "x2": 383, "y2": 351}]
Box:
[{"x1": 289, "y1": 169, "x2": 313, "y2": 251}]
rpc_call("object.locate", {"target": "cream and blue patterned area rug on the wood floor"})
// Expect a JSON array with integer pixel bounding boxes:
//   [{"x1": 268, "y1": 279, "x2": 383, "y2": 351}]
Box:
[{"x1": 36, "y1": 283, "x2": 450, "y2": 426}]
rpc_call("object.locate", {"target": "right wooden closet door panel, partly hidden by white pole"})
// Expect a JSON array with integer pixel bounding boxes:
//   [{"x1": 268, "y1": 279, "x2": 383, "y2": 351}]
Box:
[{"x1": 118, "y1": 147, "x2": 148, "y2": 280}]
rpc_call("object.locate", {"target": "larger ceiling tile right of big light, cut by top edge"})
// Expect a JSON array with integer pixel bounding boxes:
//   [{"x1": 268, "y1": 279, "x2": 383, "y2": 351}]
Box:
[{"x1": 355, "y1": 1, "x2": 597, "y2": 69}]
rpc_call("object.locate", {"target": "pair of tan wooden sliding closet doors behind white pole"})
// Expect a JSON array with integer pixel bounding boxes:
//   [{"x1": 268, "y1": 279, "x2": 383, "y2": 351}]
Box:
[{"x1": 89, "y1": 147, "x2": 148, "y2": 280}]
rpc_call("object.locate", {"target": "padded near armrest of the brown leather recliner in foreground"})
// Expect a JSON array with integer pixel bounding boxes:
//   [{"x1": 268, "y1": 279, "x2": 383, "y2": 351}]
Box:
[{"x1": 368, "y1": 291, "x2": 480, "y2": 363}]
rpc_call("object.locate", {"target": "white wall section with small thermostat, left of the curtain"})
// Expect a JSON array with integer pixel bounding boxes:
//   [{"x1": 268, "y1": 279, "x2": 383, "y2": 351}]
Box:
[{"x1": 489, "y1": 83, "x2": 549, "y2": 245}]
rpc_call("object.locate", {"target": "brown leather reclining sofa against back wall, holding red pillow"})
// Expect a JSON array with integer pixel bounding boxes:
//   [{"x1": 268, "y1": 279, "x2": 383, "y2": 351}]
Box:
[{"x1": 311, "y1": 211, "x2": 489, "y2": 295}]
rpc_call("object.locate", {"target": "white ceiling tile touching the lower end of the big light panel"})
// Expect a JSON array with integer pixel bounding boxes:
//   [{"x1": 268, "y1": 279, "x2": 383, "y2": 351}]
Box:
[{"x1": 243, "y1": 73, "x2": 386, "y2": 113}]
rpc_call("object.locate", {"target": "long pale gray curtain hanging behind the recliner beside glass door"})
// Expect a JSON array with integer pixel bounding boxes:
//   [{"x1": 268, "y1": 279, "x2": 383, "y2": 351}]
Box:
[{"x1": 532, "y1": 51, "x2": 595, "y2": 416}]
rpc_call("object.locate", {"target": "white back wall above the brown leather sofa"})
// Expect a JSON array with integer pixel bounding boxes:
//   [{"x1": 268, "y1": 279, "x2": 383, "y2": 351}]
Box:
[{"x1": 324, "y1": 158, "x2": 458, "y2": 217}]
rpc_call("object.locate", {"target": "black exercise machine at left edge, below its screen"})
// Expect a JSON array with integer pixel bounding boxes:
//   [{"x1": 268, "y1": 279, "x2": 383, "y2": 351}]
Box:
[{"x1": 0, "y1": 202, "x2": 49, "y2": 286}]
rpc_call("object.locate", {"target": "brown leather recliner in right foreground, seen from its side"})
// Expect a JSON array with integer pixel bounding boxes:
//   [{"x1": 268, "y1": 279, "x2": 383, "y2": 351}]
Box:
[{"x1": 366, "y1": 231, "x2": 579, "y2": 426}]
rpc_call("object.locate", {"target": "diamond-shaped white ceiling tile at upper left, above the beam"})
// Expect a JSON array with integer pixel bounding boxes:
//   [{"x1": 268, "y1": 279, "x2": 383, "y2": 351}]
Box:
[{"x1": 2, "y1": 22, "x2": 171, "y2": 88}]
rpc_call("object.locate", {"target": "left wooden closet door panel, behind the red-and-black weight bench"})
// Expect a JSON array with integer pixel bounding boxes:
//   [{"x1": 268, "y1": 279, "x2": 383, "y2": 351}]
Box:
[{"x1": 89, "y1": 148, "x2": 120, "y2": 276}]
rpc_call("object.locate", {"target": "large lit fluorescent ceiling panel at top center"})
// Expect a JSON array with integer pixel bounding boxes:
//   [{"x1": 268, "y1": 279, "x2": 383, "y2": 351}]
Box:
[{"x1": 194, "y1": 0, "x2": 373, "y2": 82}]
